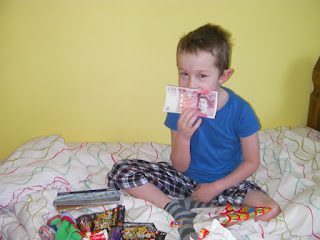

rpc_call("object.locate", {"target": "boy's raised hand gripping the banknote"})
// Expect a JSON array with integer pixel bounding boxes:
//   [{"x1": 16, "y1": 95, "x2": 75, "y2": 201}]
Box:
[{"x1": 178, "y1": 108, "x2": 202, "y2": 139}]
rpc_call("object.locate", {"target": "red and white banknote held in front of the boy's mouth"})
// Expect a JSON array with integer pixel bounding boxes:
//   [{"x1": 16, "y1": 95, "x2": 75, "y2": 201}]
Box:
[{"x1": 163, "y1": 85, "x2": 218, "y2": 118}]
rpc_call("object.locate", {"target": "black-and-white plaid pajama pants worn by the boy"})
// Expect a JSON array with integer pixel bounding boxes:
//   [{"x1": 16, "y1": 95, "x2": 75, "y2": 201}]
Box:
[{"x1": 108, "y1": 159, "x2": 263, "y2": 206}]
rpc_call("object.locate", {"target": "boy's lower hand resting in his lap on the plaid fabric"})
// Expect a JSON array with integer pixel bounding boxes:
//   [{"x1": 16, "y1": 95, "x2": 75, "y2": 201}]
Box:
[{"x1": 191, "y1": 182, "x2": 223, "y2": 203}]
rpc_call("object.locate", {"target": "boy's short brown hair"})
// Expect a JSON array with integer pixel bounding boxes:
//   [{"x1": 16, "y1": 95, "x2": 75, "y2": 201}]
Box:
[{"x1": 177, "y1": 24, "x2": 231, "y2": 74}]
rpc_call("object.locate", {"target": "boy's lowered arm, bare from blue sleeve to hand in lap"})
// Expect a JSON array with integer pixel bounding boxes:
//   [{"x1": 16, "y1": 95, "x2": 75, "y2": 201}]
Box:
[{"x1": 191, "y1": 132, "x2": 260, "y2": 203}]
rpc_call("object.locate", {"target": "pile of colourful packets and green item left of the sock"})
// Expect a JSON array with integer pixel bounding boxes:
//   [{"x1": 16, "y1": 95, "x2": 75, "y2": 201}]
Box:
[{"x1": 38, "y1": 205, "x2": 166, "y2": 240}]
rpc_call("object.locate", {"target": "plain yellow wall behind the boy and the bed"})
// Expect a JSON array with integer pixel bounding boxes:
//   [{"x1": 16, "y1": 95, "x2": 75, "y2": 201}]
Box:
[{"x1": 0, "y1": 0, "x2": 320, "y2": 159}]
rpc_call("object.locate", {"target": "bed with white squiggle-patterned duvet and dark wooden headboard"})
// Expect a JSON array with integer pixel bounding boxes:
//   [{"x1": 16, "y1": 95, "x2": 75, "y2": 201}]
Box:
[{"x1": 0, "y1": 58, "x2": 320, "y2": 240}]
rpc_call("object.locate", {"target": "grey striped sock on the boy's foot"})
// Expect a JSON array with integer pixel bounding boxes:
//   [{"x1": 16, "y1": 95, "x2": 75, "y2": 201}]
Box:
[{"x1": 164, "y1": 201, "x2": 198, "y2": 240}]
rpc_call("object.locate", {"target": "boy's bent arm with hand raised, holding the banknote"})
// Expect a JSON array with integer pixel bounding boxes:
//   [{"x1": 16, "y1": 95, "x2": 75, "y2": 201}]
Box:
[{"x1": 171, "y1": 108, "x2": 202, "y2": 172}]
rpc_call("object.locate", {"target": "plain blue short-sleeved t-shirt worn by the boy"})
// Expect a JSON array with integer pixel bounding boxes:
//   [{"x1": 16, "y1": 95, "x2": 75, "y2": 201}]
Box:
[{"x1": 165, "y1": 88, "x2": 260, "y2": 183}]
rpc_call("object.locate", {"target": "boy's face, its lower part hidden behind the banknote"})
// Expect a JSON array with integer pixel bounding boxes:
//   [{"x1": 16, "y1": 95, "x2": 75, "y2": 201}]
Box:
[{"x1": 177, "y1": 51, "x2": 224, "y2": 91}]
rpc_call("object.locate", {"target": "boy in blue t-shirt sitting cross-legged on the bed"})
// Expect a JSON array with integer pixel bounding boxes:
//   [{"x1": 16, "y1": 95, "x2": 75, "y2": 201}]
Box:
[{"x1": 108, "y1": 24, "x2": 280, "y2": 240}]
